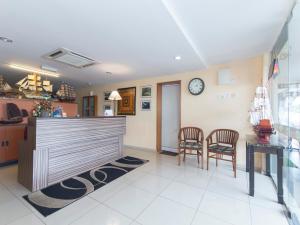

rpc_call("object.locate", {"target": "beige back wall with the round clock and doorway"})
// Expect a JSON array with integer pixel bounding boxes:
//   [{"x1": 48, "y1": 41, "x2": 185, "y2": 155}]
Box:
[{"x1": 78, "y1": 57, "x2": 263, "y2": 167}]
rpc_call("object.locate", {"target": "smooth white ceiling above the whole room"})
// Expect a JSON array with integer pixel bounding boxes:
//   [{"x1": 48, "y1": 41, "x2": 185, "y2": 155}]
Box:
[{"x1": 0, "y1": 0, "x2": 293, "y2": 86}]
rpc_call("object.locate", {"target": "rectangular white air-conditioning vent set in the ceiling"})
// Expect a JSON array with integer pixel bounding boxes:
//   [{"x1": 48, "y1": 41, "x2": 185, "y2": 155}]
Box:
[{"x1": 44, "y1": 48, "x2": 96, "y2": 68}]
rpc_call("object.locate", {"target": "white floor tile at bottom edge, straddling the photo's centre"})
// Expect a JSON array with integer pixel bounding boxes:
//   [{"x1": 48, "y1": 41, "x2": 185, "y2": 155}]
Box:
[{"x1": 137, "y1": 197, "x2": 195, "y2": 225}]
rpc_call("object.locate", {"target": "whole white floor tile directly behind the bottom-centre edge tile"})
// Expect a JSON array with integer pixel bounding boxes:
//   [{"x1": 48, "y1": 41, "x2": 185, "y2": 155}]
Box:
[{"x1": 160, "y1": 182, "x2": 204, "y2": 209}]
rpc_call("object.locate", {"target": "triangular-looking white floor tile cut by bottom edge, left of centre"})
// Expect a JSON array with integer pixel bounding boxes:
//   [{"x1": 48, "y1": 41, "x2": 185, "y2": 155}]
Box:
[{"x1": 71, "y1": 205, "x2": 133, "y2": 225}]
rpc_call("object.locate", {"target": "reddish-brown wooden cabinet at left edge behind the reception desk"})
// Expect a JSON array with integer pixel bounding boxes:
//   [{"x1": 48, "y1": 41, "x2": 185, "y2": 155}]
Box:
[{"x1": 0, "y1": 125, "x2": 25, "y2": 165}]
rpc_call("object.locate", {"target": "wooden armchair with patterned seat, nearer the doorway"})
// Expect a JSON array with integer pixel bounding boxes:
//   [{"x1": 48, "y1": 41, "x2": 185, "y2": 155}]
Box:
[{"x1": 178, "y1": 127, "x2": 204, "y2": 169}]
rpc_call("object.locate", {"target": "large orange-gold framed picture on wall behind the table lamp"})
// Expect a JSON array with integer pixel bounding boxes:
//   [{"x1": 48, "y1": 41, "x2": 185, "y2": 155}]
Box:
[{"x1": 118, "y1": 87, "x2": 136, "y2": 116}]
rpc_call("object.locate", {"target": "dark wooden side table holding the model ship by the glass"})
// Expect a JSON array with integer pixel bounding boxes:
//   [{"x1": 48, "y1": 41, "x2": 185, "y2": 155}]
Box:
[{"x1": 246, "y1": 135, "x2": 284, "y2": 204}]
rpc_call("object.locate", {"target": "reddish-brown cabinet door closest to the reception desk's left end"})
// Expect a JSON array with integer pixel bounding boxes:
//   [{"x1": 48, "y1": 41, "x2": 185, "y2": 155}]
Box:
[{"x1": 5, "y1": 126, "x2": 24, "y2": 161}]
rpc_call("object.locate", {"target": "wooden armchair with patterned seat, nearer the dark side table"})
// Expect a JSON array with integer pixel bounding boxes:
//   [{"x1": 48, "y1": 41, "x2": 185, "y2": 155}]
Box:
[{"x1": 206, "y1": 129, "x2": 239, "y2": 177}]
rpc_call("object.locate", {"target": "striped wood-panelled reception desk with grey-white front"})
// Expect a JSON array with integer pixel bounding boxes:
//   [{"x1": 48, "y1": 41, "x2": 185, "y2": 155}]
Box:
[{"x1": 18, "y1": 117, "x2": 126, "y2": 191}]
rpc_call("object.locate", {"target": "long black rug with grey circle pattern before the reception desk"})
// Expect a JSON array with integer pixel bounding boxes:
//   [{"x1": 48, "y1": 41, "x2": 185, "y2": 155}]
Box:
[{"x1": 23, "y1": 156, "x2": 148, "y2": 217}]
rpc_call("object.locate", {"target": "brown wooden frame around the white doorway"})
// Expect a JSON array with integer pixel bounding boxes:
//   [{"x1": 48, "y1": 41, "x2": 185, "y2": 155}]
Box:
[{"x1": 156, "y1": 80, "x2": 181, "y2": 152}]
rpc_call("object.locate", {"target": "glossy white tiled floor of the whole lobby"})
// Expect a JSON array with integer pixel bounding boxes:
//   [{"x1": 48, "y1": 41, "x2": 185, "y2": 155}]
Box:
[{"x1": 0, "y1": 149, "x2": 288, "y2": 225}]
